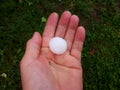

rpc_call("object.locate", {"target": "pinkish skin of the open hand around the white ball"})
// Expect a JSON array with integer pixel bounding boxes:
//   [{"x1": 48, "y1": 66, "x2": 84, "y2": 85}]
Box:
[{"x1": 20, "y1": 11, "x2": 85, "y2": 90}]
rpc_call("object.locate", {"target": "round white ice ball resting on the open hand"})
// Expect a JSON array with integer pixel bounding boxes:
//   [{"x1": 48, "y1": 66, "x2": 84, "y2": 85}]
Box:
[{"x1": 49, "y1": 37, "x2": 67, "y2": 54}]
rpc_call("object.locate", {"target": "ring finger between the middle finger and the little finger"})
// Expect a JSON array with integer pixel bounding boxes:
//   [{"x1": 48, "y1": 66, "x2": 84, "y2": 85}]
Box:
[{"x1": 65, "y1": 15, "x2": 79, "y2": 50}]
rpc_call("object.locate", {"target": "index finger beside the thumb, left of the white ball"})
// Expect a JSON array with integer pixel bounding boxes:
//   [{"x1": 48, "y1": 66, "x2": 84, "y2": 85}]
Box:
[{"x1": 42, "y1": 13, "x2": 58, "y2": 47}]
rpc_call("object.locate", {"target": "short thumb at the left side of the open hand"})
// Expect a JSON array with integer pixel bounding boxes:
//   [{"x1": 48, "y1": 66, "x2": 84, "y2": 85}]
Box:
[{"x1": 24, "y1": 32, "x2": 42, "y2": 59}]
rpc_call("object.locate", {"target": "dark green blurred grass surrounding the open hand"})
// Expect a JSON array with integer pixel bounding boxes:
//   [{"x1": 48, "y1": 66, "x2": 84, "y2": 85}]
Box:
[{"x1": 0, "y1": 0, "x2": 120, "y2": 90}]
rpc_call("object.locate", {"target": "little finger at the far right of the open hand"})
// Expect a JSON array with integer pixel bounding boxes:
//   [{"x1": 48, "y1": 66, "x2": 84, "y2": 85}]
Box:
[{"x1": 71, "y1": 26, "x2": 85, "y2": 59}]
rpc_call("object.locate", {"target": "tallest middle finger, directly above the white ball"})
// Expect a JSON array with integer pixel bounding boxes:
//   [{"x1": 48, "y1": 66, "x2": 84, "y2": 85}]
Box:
[{"x1": 55, "y1": 11, "x2": 71, "y2": 37}]
